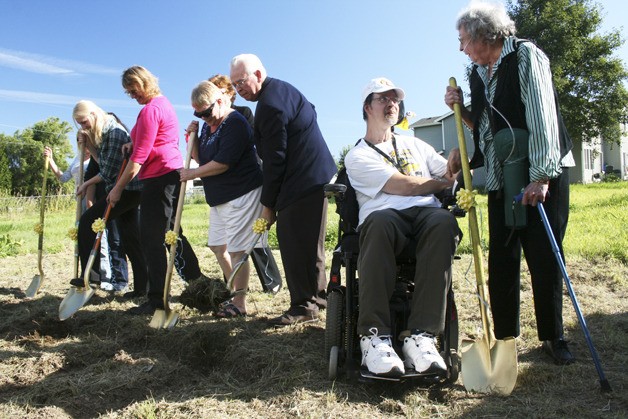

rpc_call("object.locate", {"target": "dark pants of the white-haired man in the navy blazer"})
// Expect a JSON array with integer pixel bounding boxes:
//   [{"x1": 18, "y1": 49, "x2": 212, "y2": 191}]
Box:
[{"x1": 277, "y1": 187, "x2": 327, "y2": 315}]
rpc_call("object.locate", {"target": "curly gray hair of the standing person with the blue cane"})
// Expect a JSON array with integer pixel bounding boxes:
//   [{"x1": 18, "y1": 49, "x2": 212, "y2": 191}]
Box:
[{"x1": 456, "y1": 0, "x2": 517, "y2": 43}]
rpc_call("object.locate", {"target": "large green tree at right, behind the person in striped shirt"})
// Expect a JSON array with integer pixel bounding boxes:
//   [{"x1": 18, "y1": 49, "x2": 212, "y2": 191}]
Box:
[{"x1": 508, "y1": 0, "x2": 628, "y2": 143}]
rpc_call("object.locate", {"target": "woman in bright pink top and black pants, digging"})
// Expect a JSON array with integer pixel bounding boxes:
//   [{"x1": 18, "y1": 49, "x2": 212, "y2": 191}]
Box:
[{"x1": 108, "y1": 66, "x2": 201, "y2": 315}]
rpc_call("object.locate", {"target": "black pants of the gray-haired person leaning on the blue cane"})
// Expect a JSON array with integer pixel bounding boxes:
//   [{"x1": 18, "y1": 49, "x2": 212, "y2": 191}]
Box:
[{"x1": 488, "y1": 168, "x2": 569, "y2": 340}]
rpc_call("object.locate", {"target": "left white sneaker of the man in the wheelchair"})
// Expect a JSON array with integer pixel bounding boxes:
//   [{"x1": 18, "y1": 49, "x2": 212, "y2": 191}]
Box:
[{"x1": 360, "y1": 327, "x2": 405, "y2": 377}]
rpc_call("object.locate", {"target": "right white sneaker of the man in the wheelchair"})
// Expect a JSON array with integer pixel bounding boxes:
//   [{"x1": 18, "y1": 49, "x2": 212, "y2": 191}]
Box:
[{"x1": 402, "y1": 332, "x2": 447, "y2": 374}]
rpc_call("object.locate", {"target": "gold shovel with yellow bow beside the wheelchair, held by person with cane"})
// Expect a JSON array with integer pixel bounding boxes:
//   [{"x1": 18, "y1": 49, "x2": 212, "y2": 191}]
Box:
[{"x1": 449, "y1": 77, "x2": 517, "y2": 395}]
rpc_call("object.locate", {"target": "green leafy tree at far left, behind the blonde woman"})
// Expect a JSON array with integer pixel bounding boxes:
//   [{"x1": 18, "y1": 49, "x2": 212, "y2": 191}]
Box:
[{"x1": 3, "y1": 117, "x2": 72, "y2": 196}]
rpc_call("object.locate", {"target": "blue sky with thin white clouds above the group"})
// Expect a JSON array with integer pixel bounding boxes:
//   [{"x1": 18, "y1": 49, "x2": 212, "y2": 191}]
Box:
[{"x1": 0, "y1": 0, "x2": 628, "y2": 162}]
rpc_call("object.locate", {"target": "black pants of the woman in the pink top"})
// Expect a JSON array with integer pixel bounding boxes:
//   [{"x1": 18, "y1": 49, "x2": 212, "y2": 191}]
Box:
[{"x1": 140, "y1": 170, "x2": 201, "y2": 307}]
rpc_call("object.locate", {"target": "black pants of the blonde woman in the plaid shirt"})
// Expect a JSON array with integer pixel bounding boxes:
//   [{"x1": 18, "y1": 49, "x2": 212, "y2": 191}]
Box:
[{"x1": 78, "y1": 190, "x2": 148, "y2": 291}]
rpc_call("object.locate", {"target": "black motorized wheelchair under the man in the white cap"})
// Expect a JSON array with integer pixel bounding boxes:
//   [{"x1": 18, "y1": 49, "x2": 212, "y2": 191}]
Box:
[{"x1": 324, "y1": 168, "x2": 465, "y2": 384}]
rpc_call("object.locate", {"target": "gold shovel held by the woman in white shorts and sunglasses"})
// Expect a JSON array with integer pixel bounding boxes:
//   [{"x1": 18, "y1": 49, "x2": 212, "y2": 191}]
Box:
[{"x1": 148, "y1": 132, "x2": 196, "y2": 329}]
